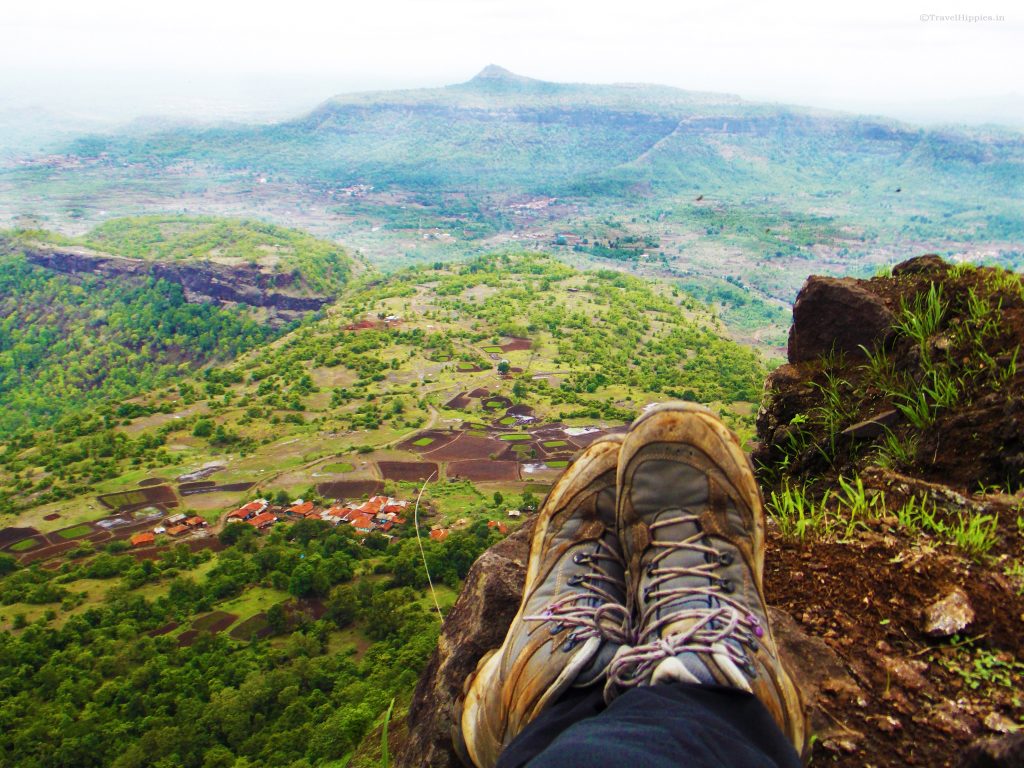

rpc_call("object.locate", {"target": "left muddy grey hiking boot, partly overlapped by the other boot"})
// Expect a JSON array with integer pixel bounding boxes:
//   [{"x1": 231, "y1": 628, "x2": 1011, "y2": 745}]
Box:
[{"x1": 454, "y1": 436, "x2": 630, "y2": 768}]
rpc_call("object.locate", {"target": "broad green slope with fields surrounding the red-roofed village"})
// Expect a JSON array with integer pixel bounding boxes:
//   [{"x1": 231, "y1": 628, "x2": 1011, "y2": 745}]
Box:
[{"x1": 0, "y1": 254, "x2": 765, "y2": 768}]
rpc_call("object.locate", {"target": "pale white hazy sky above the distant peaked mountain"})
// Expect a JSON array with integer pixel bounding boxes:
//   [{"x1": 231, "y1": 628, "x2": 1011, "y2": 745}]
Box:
[{"x1": 0, "y1": 0, "x2": 1024, "y2": 122}]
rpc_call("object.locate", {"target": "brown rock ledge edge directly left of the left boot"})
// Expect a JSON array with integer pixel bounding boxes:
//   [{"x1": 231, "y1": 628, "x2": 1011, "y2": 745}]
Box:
[{"x1": 394, "y1": 520, "x2": 534, "y2": 768}]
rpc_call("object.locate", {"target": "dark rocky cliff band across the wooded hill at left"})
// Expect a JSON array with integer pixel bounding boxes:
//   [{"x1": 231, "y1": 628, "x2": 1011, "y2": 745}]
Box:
[{"x1": 24, "y1": 246, "x2": 329, "y2": 325}]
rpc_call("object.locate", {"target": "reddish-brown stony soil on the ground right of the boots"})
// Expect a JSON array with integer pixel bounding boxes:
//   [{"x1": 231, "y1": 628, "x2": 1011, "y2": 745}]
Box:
[{"x1": 765, "y1": 531, "x2": 1024, "y2": 768}]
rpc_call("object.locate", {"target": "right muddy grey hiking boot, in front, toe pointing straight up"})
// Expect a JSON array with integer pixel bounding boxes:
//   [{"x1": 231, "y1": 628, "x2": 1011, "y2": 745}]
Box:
[{"x1": 605, "y1": 402, "x2": 806, "y2": 753}]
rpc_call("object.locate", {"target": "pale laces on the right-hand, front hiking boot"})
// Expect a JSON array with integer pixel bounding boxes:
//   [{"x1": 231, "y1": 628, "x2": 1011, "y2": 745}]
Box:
[{"x1": 606, "y1": 514, "x2": 764, "y2": 690}]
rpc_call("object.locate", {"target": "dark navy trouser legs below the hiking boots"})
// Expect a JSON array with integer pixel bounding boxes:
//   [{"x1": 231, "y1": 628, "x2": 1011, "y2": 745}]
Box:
[{"x1": 498, "y1": 684, "x2": 801, "y2": 768}]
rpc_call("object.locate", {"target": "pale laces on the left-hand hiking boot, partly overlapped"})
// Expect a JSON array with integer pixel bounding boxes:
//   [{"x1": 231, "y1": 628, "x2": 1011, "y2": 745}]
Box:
[{"x1": 523, "y1": 537, "x2": 634, "y2": 653}]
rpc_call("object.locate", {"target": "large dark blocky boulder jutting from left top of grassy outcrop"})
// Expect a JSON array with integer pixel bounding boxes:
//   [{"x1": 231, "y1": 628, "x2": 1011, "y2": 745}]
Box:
[{"x1": 788, "y1": 275, "x2": 893, "y2": 362}]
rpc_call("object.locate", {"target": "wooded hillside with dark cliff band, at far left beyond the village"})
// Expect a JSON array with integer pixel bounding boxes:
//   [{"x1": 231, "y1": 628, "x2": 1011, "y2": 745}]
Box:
[{"x1": 0, "y1": 217, "x2": 351, "y2": 436}]
